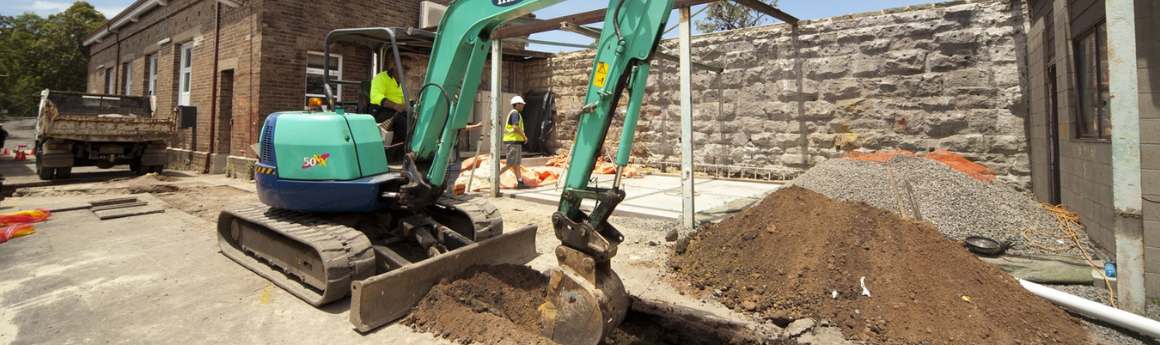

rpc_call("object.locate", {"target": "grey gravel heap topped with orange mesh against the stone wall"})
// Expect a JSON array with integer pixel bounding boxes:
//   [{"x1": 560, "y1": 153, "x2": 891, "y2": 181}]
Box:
[{"x1": 791, "y1": 154, "x2": 1095, "y2": 256}]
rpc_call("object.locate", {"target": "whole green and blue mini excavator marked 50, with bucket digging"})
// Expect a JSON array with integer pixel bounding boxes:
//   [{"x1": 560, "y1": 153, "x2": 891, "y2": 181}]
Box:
[{"x1": 218, "y1": 0, "x2": 673, "y2": 344}]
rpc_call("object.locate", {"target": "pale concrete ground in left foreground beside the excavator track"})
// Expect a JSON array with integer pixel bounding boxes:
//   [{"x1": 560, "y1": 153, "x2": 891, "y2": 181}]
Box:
[{"x1": 0, "y1": 192, "x2": 451, "y2": 345}]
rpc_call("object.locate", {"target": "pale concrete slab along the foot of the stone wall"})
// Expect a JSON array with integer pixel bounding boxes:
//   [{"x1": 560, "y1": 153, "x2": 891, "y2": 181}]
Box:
[{"x1": 496, "y1": 174, "x2": 782, "y2": 220}]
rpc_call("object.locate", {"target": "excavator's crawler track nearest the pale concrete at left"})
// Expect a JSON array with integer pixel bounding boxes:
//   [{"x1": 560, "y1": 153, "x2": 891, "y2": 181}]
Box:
[{"x1": 218, "y1": 204, "x2": 375, "y2": 307}]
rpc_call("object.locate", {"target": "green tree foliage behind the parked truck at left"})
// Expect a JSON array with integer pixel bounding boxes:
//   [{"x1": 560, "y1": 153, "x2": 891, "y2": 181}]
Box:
[{"x1": 0, "y1": 1, "x2": 107, "y2": 116}]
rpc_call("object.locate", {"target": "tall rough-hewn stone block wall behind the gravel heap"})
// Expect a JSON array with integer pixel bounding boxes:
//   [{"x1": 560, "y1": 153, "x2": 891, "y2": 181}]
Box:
[{"x1": 521, "y1": 0, "x2": 1030, "y2": 187}]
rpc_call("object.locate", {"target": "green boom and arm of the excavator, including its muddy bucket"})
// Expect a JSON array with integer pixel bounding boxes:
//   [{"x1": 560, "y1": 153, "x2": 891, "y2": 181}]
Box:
[{"x1": 400, "y1": 0, "x2": 673, "y2": 344}]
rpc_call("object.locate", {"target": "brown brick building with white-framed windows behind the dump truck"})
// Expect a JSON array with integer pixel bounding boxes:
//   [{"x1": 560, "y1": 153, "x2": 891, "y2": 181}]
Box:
[{"x1": 81, "y1": 0, "x2": 527, "y2": 173}]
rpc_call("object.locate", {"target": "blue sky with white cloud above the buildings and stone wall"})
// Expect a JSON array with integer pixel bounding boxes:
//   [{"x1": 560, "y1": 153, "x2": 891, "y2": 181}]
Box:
[{"x1": 0, "y1": 0, "x2": 940, "y2": 52}]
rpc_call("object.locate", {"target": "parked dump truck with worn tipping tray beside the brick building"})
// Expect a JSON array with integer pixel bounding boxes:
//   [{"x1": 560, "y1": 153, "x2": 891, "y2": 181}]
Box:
[{"x1": 32, "y1": 89, "x2": 177, "y2": 180}]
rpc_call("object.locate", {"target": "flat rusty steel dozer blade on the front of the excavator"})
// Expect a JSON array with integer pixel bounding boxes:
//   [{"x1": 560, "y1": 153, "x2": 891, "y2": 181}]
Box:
[{"x1": 350, "y1": 221, "x2": 537, "y2": 332}]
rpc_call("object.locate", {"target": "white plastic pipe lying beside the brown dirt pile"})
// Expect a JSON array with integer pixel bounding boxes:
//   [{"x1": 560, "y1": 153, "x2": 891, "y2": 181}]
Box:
[{"x1": 1018, "y1": 279, "x2": 1160, "y2": 338}]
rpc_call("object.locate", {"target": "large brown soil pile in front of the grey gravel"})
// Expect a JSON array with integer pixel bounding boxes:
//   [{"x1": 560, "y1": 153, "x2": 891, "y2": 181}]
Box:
[{"x1": 669, "y1": 187, "x2": 1090, "y2": 344}]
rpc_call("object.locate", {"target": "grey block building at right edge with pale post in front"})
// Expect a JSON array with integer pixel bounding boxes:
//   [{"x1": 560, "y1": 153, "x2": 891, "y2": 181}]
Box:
[{"x1": 1028, "y1": 0, "x2": 1160, "y2": 311}]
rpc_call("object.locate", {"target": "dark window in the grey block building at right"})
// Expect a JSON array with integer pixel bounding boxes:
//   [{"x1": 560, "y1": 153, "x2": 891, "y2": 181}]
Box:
[{"x1": 1075, "y1": 23, "x2": 1111, "y2": 141}]
